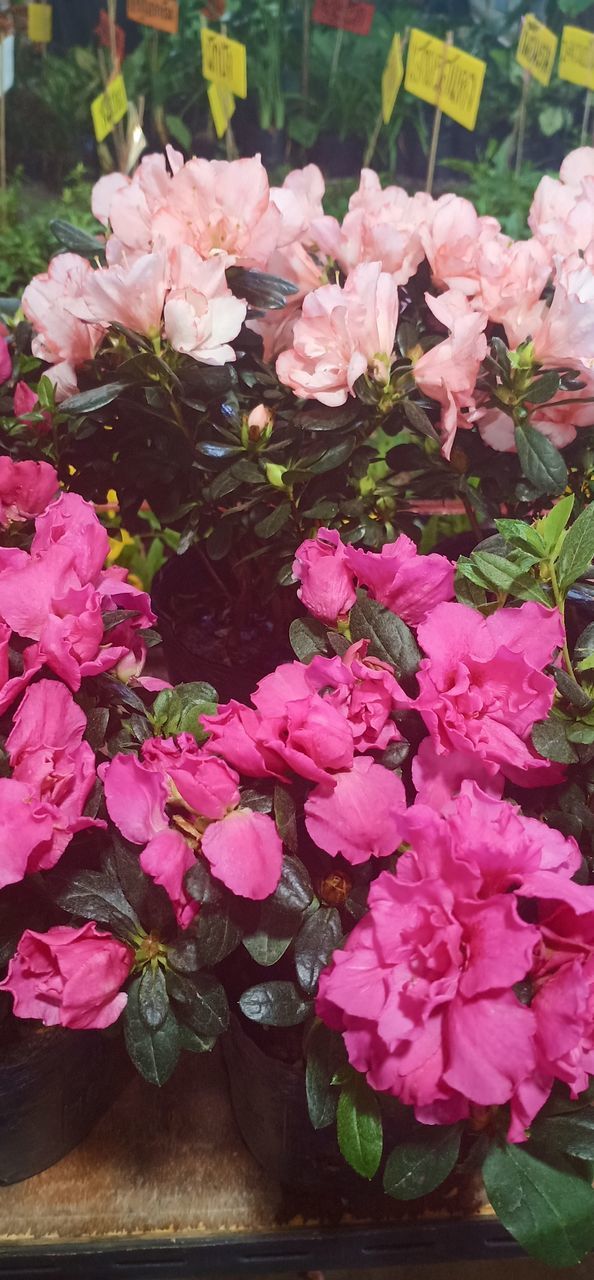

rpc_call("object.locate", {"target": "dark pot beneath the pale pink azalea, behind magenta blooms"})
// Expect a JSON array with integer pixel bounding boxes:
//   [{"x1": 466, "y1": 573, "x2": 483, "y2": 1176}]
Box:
[{"x1": 152, "y1": 548, "x2": 293, "y2": 703}]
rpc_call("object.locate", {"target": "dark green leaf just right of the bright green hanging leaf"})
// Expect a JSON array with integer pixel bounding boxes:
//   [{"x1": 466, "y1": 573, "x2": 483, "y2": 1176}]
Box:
[{"x1": 384, "y1": 1124, "x2": 462, "y2": 1201}]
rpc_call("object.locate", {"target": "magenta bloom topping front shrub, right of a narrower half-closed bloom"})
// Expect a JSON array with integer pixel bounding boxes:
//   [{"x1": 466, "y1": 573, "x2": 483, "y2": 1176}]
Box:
[{"x1": 346, "y1": 534, "x2": 456, "y2": 627}]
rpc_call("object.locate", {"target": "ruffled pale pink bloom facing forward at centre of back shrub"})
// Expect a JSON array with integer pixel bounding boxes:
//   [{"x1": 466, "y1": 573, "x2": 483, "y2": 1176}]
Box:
[{"x1": 277, "y1": 262, "x2": 398, "y2": 406}]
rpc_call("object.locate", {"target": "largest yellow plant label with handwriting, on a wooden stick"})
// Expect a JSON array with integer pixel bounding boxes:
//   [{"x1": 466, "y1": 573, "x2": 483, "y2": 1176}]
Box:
[{"x1": 405, "y1": 28, "x2": 486, "y2": 129}]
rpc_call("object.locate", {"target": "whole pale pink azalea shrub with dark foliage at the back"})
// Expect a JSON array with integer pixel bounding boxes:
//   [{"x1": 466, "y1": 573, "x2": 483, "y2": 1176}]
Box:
[{"x1": 0, "y1": 147, "x2": 594, "y2": 624}]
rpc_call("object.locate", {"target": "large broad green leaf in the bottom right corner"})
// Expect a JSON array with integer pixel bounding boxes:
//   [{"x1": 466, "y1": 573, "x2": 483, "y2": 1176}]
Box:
[{"x1": 483, "y1": 1143, "x2": 594, "y2": 1267}]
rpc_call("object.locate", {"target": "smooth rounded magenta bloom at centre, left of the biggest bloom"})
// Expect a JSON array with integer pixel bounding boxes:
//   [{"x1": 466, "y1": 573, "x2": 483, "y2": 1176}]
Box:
[{"x1": 303, "y1": 755, "x2": 406, "y2": 867}]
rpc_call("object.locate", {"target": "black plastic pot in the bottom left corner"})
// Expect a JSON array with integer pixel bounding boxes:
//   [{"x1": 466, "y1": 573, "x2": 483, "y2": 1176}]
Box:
[{"x1": 0, "y1": 1016, "x2": 128, "y2": 1187}]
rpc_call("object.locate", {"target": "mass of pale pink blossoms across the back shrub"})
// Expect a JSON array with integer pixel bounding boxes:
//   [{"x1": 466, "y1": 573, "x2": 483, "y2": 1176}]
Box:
[{"x1": 17, "y1": 147, "x2": 594, "y2": 454}]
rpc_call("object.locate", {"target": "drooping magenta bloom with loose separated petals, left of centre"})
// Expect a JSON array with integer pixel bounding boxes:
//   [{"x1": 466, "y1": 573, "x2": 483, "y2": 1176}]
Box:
[{"x1": 100, "y1": 733, "x2": 283, "y2": 928}]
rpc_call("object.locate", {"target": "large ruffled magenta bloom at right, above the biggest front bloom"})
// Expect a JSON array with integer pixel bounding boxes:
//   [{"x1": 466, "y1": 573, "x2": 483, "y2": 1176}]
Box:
[{"x1": 412, "y1": 602, "x2": 562, "y2": 786}]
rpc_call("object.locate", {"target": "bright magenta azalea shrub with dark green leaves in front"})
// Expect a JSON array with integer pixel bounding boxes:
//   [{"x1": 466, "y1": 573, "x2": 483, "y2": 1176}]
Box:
[{"x1": 5, "y1": 483, "x2": 594, "y2": 1266}]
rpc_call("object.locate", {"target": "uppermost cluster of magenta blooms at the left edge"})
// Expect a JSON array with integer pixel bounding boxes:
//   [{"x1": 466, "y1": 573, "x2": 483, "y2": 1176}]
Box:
[{"x1": 0, "y1": 483, "x2": 155, "y2": 710}]
